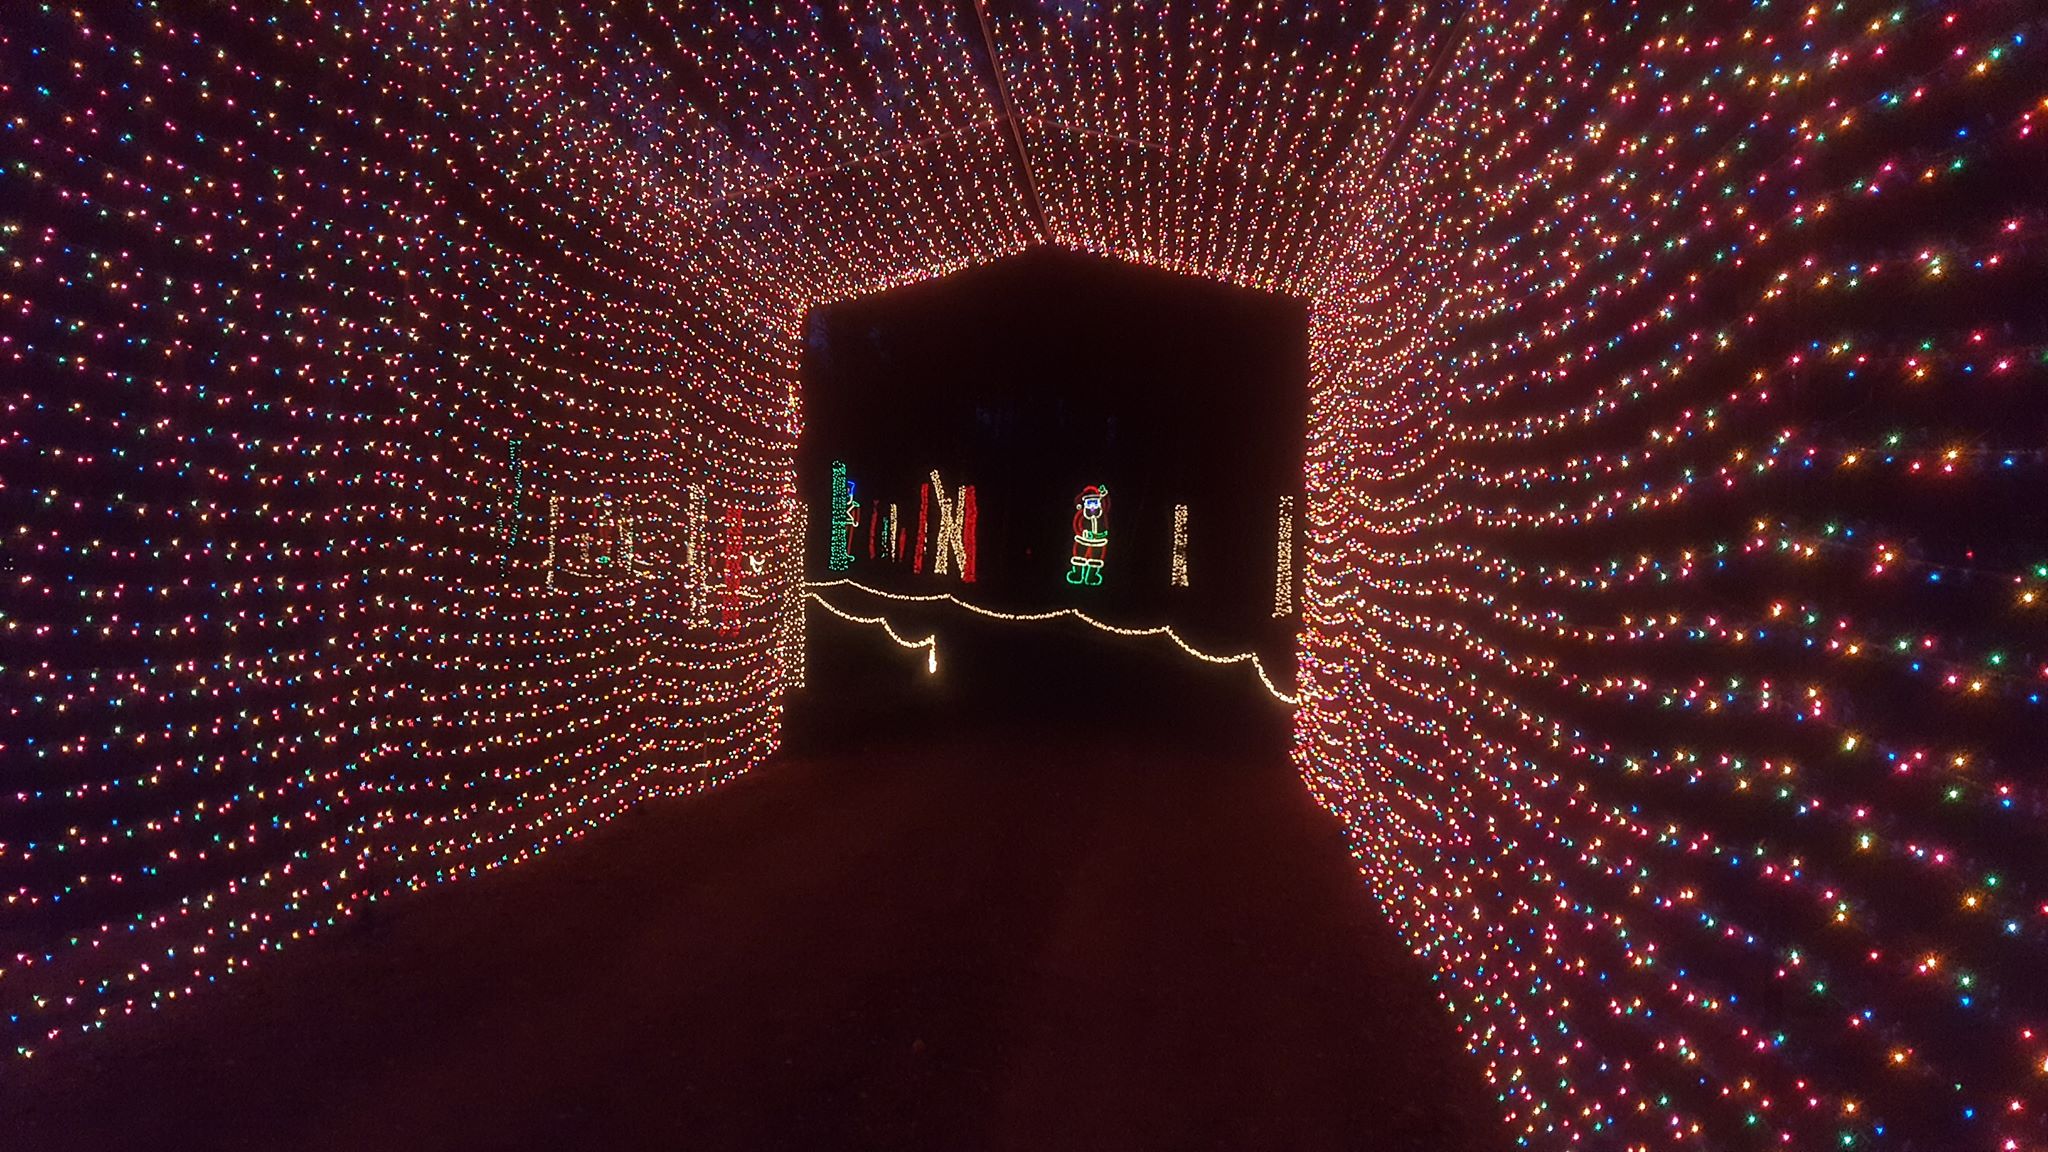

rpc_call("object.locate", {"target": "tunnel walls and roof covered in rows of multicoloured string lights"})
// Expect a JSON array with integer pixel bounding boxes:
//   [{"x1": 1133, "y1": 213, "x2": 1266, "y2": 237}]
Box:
[{"x1": 0, "y1": 0, "x2": 2048, "y2": 1150}]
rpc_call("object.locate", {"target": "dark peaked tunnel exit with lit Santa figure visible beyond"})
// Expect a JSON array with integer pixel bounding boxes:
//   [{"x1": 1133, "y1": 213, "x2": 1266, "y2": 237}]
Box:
[{"x1": 797, "y1": 248, "x2": 1309, "y2": 707}]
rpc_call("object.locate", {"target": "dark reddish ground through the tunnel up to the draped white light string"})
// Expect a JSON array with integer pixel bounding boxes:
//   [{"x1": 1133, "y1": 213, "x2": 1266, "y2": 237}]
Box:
[{"x1": 0, "y1": 607, "x2": 1499, "y2": 1152}]
